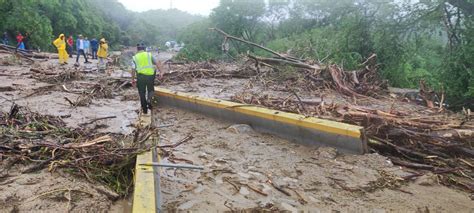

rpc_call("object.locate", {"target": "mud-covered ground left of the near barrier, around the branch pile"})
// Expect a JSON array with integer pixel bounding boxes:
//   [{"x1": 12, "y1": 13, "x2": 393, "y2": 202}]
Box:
[{"x1": 0, "y1": 54, "x2": 138, "y2": 212}]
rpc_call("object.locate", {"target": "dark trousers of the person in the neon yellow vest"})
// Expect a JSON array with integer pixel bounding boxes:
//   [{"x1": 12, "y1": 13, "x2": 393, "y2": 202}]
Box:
[{"x1": 137, "y1": 74, "x2": 155, "y2": 114}]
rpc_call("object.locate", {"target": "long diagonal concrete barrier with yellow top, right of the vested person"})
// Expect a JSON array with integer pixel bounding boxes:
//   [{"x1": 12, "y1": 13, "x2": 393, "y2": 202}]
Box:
[{"x1": 155, "y1": 87, "x2": 367, "y2": 154}]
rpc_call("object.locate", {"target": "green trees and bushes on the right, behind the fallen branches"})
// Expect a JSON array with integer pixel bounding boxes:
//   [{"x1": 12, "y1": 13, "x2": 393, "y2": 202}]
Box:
[{"x1": 179, "y1": 0, "x2": 474, "y2": 109}]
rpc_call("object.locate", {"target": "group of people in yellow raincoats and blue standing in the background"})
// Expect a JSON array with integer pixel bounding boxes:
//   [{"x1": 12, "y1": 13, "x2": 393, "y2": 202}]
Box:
[{"x1": 53, "y1": 34, "x2": 109, "y2": 70}]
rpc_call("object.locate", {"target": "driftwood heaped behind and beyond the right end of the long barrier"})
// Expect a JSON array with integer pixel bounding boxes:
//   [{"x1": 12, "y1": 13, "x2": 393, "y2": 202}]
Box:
[{"x1": 232, "y1": 91, "x2": 474, "y2": 192}]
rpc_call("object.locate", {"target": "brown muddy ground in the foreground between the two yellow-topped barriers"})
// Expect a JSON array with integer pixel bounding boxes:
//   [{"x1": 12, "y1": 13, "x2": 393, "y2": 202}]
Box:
[{"x1": 154, "y1": 108, "x2": 474, "y2": 212}]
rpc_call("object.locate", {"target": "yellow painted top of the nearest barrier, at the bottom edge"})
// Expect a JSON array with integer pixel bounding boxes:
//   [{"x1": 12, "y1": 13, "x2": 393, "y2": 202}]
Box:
[{"x1": 132, "y1": 151, "x2": 156, "y2": 213}]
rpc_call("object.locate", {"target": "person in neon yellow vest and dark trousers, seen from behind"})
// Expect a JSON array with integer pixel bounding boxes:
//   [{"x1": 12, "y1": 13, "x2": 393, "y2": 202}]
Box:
[{"x1": 132, "y1": 44, "x2": 163, "y2": 115}]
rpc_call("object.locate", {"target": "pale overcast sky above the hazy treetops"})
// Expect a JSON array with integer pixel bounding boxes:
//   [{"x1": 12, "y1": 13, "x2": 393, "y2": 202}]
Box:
[{"x1": 118, "y1": 0, "x2": 219, "y2": 16}]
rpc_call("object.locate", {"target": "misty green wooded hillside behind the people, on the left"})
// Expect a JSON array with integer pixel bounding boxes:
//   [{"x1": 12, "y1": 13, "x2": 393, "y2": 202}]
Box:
[{"x1": 0, "y1": 0, "x2": 203, "y2": 50}]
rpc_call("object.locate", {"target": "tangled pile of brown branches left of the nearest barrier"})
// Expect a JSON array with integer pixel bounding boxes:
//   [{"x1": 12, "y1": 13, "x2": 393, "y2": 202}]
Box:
[{"x1": 0, "y1": 105, "x2": 153, "y2": 195}]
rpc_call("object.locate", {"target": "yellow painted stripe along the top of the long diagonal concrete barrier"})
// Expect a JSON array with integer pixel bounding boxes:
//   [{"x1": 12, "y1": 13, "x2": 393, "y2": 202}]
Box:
[{"x1": 155, "y1": 87, "x2": 363, "y2": 138}]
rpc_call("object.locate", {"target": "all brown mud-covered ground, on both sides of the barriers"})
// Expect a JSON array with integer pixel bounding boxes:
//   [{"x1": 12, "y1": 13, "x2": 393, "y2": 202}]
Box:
[{"x1": 0, "y1": 54, "x2": 474, "y2": 212}]
